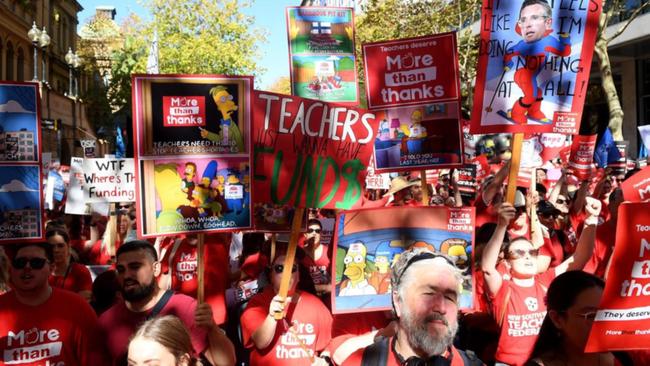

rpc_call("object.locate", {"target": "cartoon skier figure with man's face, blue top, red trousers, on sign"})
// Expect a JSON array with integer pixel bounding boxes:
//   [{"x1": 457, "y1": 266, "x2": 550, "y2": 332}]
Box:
[{"x1": 503, "y1": 0, "x2": 571, "y2": 125}]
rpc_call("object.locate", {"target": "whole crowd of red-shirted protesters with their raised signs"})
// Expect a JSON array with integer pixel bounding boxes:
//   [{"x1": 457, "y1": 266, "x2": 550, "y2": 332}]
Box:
[{"x1": 0, "y1": 0, "x2": 650, "y2": 366}]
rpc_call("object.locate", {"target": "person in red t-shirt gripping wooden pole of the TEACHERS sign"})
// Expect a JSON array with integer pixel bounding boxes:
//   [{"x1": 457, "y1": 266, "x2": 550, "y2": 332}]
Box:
[{"x1": 241, "y1": 247, "x2": 332, "y2": 366}]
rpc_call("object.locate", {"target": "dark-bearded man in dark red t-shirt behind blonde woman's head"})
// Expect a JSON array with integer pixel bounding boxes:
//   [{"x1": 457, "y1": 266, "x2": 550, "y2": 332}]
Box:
[{"x1": 99, "y1": 240, "x2": 235, "y2": 365}]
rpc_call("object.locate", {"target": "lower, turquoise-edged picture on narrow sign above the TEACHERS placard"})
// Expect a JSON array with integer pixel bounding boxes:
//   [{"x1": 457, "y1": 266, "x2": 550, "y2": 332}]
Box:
[{"x1": 292, "y1": 55, "x2": 357, "y2": 102}]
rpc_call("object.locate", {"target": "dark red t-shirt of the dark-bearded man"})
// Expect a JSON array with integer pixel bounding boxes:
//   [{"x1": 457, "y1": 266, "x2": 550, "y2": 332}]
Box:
[{"x1": 99, "y1": 294, "x2": 208, "y2": 365}]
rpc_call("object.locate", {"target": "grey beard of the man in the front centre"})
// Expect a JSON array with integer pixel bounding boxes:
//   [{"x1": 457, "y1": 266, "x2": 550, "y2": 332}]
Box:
[{"x1": 400, "y1": 311, "x2": 458, "y2": 357}]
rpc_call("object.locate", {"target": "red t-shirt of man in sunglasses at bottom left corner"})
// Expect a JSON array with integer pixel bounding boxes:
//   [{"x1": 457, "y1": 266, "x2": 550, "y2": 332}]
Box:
[{"x1": 0, "y1": 288, "x2": 107, "y2": 366}]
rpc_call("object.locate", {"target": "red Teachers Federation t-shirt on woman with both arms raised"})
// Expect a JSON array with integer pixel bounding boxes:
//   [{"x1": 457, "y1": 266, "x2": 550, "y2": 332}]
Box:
[{"x1": 491, "y1": 269, "x2": 555, "y2": 366}]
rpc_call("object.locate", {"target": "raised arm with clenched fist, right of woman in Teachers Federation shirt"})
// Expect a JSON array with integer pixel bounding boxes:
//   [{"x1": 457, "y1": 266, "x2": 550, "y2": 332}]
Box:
[{"x1": 555, "y1": 197, "x2": 601, "y2": 275}]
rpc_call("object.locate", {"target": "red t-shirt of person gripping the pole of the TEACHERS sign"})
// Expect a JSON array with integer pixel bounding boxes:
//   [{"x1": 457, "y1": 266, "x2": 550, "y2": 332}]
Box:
[{"x1": 241, "y1": 286, "x2": 332, "y2": 365}]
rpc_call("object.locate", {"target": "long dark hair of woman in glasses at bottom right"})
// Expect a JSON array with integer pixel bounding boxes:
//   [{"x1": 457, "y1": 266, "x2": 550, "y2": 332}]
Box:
[{"x1": 530, "y1": 271, "x2": 605, "y2": 359}]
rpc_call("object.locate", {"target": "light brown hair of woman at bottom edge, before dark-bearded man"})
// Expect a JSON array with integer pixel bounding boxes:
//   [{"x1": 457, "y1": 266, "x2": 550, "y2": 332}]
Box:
[{"x1": 129, "y1": 315, "x2": 197, "y2": 365}]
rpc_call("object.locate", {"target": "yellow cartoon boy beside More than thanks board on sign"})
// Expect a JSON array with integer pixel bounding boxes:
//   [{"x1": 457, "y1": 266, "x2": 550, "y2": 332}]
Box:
[{"x1": 199, "y1": 85, "x2": 244, "y2": 153}]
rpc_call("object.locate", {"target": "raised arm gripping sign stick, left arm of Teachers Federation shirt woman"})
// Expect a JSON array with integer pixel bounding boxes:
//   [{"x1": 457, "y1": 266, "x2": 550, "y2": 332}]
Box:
[{"x1": 481, "y1": 202, "x2": 515, "y2": 295}]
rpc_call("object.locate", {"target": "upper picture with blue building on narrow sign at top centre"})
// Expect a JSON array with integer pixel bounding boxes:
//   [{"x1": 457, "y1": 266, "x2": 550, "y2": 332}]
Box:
[{"x1": 287, "y1": 6, "x2": 354, "y2": 55}]
